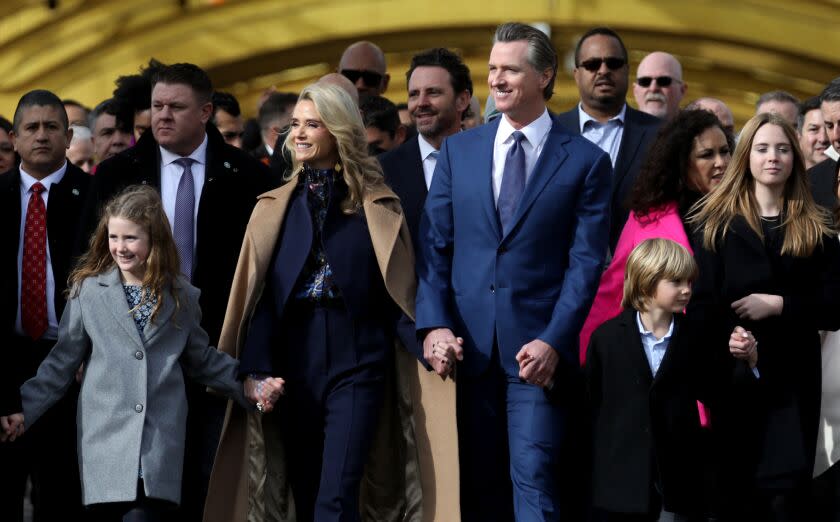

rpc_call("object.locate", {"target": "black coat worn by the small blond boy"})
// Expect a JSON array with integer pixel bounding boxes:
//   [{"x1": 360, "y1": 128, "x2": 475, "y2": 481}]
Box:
[{"x1": 585, "y1": 309, "x2": 710, "y2": 513}]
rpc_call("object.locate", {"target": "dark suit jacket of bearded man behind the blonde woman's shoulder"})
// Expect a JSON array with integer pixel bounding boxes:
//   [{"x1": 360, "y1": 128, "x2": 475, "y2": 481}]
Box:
[{"x1": 378, "y1": 136, "x2": 429, "y2": 247}]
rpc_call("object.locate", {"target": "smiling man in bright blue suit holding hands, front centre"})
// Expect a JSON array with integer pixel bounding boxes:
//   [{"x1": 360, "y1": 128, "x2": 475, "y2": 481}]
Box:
[{"x1": 417, "y1": 23, "x2": 612, "y2": 522}]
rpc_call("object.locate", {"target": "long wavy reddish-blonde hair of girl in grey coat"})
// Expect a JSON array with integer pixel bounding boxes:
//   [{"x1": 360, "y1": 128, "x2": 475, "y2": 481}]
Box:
[{"x1": 67, "y1": 185, "x2": 181, "y2": 322}]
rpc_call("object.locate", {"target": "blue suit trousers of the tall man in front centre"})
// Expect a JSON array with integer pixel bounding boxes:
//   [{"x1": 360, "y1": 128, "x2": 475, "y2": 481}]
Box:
[{"x1": 457, "y1": 350, "x2": 578, "y2": 522}]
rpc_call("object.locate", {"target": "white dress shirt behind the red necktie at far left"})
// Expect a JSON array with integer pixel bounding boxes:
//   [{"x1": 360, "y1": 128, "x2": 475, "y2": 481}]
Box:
[{"x1": 15, "y1": 161, "x2": 67, "y2": 341}]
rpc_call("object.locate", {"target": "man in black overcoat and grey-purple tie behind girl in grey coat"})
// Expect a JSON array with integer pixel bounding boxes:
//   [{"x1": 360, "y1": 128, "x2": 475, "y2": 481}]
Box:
[{"x1": 86, "y1": 64, "x2": 277, "y2": 520}]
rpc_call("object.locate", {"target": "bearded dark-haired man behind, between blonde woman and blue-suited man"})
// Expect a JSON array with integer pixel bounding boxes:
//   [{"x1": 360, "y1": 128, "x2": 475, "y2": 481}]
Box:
[{"x1": 379, "y1": 48, "x2": 473, "y2": 245}]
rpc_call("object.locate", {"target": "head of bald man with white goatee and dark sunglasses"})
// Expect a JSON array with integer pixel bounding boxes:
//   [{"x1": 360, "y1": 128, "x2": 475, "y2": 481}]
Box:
[{"x1": 633, "y1": 51, "x2": 688, "y2": 120}]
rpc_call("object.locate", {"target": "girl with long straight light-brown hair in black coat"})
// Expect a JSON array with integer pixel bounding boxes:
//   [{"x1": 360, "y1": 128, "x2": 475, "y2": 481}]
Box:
[{"x1": 686, "y1": 113, "x2": 840, "y2": 521}]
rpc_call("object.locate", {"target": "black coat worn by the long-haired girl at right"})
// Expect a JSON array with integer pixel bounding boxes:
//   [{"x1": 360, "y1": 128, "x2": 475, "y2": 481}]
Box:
[{"x1": 687, "y1": 217, "x2": 840, "y2": 492}]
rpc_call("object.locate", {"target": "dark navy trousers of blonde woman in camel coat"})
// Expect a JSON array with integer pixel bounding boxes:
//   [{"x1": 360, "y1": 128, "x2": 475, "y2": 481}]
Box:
[{"x1": 275, "y1": 304, "x2": 389, "y2": 522}]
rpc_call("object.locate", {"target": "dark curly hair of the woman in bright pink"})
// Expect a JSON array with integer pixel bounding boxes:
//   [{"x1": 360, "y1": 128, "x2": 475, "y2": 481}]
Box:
[{"x1": 627, "y1": 109, "x2": 735, "y2": 218}]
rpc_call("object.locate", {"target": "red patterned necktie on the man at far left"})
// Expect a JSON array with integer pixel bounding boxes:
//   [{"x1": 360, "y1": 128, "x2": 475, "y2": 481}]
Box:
[{"x1": 20, "y1": 182, "x2": 47, "y2": 340}]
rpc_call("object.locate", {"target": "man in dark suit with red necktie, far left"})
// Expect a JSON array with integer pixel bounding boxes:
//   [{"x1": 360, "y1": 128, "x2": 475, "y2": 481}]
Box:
[{"x1": 0, "y1": 90, "x2": 90, "y2": 521}]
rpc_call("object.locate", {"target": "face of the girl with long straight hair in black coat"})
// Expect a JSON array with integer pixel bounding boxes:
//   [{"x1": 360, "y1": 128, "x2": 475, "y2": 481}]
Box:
[{"x1": 750, "y1": 123, "x2": 793, "y2": 190}]
